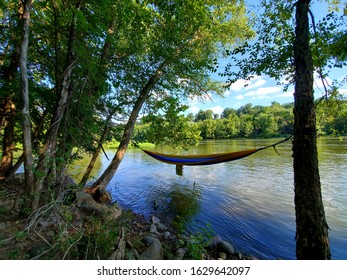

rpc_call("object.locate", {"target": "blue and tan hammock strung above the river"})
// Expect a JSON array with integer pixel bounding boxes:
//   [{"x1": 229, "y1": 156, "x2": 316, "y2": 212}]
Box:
[{"x1": 143, "y1": 136, "x2": 292, "y2": 168}]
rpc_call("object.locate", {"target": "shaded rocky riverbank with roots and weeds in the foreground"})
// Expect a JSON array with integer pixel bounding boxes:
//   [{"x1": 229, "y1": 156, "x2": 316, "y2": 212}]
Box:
[{"x1": 0, "y1": 175, "x2": 254, "y2": 260}]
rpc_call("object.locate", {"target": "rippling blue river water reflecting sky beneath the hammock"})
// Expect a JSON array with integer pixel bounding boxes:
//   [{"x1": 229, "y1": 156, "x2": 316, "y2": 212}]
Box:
[{"x1": 72, "y1": 139, "x2": 347, "y2": 260}]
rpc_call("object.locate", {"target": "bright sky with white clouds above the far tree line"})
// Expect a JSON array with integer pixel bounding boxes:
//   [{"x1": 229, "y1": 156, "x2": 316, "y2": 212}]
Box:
[{"x1": 187, "y1": 1, "x2": 347, "y2": 114}]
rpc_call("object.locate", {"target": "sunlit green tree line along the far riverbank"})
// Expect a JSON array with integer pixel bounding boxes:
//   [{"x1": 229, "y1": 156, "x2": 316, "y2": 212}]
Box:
[{"x1": 132, "y1": 98, "x2": 347, "y2": 148}]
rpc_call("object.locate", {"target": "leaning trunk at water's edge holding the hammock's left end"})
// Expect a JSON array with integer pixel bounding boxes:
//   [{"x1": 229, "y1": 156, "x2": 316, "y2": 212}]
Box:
[{"x1": 88, "y1": 63, "x2": 167, "y2": 193}]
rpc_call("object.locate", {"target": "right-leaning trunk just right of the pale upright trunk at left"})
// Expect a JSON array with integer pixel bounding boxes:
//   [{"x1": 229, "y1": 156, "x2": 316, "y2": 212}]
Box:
[{"x1": 31, "y1": 1, "x2": 81, "y2": 210}]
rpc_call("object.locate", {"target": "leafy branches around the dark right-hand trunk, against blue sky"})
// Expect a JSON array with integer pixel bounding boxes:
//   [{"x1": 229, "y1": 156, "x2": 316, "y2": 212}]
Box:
[{"x1": 221, "y1": 0, "x2": 346, "y2": 92}]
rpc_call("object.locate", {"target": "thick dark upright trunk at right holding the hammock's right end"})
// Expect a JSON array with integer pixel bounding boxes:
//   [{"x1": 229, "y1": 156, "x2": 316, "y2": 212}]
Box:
[{"x1": 293, "y1": 0, "x2": 331, "y2": 259}]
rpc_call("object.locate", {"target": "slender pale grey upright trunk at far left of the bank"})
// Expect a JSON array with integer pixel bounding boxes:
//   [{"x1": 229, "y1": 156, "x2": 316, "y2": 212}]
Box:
[{"x1": 19, "y1": 0, "x2": 34, "y2": 192}]
